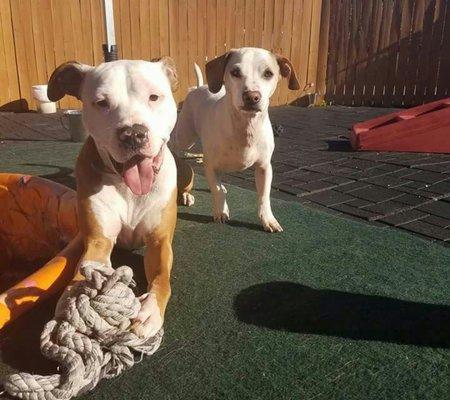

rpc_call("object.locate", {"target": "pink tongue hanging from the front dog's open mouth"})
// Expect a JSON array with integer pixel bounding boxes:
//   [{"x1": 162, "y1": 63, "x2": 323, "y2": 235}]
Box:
[{"x1": 123, "y1": 158, "x2": 154, "y2": 195}]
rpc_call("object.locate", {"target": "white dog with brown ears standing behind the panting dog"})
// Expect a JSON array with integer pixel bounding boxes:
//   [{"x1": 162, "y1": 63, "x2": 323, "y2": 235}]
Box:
[{"x1": 173, "y1": 48, "x2": 299, "y2": 232}]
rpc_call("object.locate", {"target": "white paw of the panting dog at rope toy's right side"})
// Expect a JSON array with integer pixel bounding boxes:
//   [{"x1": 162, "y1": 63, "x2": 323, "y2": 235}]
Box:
[{"x1": 131, "y1": 293, "x2": 164, "y2": 338}]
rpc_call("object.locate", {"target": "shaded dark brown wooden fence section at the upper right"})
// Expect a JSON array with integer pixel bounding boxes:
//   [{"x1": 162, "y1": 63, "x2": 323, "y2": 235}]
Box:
[{"x1": 322, "y1": 0, "x2": 450, "y2": 106}]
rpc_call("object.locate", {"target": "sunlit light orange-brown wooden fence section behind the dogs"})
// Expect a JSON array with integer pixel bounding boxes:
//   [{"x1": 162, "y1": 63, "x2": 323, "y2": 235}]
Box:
[{"x1": 0, "y1": 0, "x2": 326, "y2": 110}]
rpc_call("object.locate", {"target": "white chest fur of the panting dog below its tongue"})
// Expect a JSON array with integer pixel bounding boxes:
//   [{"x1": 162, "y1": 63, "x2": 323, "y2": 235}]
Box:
[{"x1": 89, "y1": 149, "x2": 177, "y2": 248}]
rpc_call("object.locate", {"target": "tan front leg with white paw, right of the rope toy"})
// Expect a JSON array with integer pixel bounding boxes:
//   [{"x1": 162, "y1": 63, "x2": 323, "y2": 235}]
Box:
[{"x1": 132, "y1": 192, "x2": 177, "y2": 337}]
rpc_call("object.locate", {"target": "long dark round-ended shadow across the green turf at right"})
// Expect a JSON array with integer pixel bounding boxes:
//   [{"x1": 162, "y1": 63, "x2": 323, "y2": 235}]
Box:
[{"x1": 234, "y1": 282, "x2": 450, "y2": 348}]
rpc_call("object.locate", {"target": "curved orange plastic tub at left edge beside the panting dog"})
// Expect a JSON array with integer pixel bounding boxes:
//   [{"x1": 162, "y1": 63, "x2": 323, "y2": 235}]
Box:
[{"x1": 0, "y1": 173, "x2": 83, "y2": 329}]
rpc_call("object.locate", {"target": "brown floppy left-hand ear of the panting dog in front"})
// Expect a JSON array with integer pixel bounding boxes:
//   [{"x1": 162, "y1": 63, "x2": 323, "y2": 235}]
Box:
[{"x1": 47, "y1": 61, "x2": 92, "y2": 101}]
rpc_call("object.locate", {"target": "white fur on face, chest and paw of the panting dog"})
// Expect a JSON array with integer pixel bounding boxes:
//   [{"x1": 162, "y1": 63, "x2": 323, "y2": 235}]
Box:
[{"x1": 76, "y1": 61, "x2": 177, "y2": 336}]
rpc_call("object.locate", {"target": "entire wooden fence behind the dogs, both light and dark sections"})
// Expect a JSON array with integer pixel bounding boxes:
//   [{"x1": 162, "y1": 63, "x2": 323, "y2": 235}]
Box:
[{"x1": 0, "y1": 0, "x2": 450, "y2": 110}]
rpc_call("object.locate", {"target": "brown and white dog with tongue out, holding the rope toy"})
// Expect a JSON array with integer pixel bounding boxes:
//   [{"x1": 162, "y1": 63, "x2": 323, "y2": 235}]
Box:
[{"x1": 48, "y1": 57, "x2": 185, "y2": 337}]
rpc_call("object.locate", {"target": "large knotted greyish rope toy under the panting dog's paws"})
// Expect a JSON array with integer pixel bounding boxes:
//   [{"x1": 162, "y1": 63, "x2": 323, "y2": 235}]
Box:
[{"x1": 3, "y1": 263, "x2": 163, "y2": 400}]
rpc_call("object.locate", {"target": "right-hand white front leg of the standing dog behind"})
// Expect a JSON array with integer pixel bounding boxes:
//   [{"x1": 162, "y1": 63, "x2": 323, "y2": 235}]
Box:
[{"x1": 255, "y1": 163, "x2": 283, "y2": 232}]
